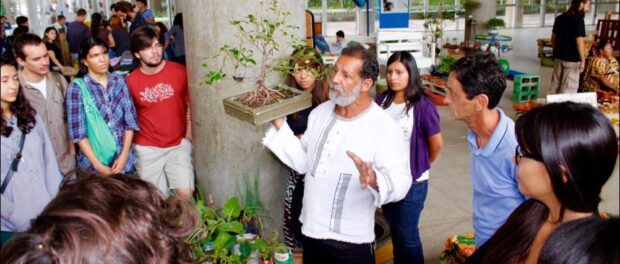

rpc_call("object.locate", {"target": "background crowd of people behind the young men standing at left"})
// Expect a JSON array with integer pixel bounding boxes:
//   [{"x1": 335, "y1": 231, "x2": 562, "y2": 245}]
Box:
[{"x1": 0, "y1": 0, "x2": 185, "y2": 69}]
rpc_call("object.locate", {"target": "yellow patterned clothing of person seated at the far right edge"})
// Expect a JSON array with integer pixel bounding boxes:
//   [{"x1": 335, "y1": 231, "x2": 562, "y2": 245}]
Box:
[{"x1": 583, "y1": 56, "x2": 619, "y2": 93}]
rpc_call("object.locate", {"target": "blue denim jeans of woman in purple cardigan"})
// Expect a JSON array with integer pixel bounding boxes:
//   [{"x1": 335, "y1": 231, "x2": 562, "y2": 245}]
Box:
[{"x1": 382, "y1": 181, "x2": 428, "y2": 264}]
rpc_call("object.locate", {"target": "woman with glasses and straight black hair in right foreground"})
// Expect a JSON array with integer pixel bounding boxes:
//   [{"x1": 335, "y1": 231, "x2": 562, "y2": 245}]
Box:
[{"x1": 468, "y1": 102, "x2": 618, "y2": 263}]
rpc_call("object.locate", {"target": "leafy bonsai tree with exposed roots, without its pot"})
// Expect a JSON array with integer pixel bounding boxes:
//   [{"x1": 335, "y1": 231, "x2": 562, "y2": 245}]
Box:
[{"x1": 202, "y1": 0, "x2": 302, "y2": 107}]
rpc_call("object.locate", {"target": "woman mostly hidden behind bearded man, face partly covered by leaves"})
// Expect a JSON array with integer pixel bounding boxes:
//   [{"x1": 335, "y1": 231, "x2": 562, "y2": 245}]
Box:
[{"x1": 283, "y1": 46, "x2": 328, "y2": 248}]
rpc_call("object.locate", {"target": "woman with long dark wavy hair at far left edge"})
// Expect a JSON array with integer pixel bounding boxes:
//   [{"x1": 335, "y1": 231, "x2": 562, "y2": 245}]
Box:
[{"x1": 0, "y1": 57, "x2": 62, "y2": 244}]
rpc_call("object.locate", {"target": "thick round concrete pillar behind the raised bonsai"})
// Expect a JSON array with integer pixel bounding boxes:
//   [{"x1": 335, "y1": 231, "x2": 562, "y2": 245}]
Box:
[{"x1": 183, "y1": 0, "x2": 305, "y2": 230}]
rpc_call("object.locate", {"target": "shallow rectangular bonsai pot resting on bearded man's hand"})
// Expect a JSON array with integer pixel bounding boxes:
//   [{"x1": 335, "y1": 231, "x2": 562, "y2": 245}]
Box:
[{"x1": 224, "y1": 84, "x2": 312, "y2": 125}]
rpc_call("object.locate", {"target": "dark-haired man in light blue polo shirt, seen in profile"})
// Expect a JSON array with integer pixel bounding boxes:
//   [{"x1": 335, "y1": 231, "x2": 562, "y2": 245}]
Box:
[{"x1": 445, "y1": 54, "x2": 525, "y2": 247}]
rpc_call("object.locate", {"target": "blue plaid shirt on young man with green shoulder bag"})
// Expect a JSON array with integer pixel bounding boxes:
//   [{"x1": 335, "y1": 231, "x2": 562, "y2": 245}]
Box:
[{"x1": 66, "y1": 73, "x2": 140, "y2": 173}]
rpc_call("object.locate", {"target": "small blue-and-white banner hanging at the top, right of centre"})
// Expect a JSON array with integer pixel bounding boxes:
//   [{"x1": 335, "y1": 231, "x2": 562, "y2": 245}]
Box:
[{"x1": 377, "y1": 0, "x2": 410, "y2": 28}]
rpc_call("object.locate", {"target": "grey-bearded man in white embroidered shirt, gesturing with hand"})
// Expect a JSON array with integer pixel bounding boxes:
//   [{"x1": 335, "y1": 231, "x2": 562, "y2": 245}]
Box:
[{"x1": 263, "y1": 45, "x2": 411, "y2": 263}]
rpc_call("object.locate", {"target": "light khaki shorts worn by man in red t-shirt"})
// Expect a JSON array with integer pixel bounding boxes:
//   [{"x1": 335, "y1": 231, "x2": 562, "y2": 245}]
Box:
[{"x1": 135, "y1": 139, "x2": 194, "y2": 196}]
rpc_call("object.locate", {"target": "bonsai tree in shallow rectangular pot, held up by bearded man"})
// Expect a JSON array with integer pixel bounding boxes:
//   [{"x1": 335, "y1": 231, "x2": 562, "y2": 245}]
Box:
[{"x1": 203, "y1": 0, "x2": 312, "y2": 125}]
